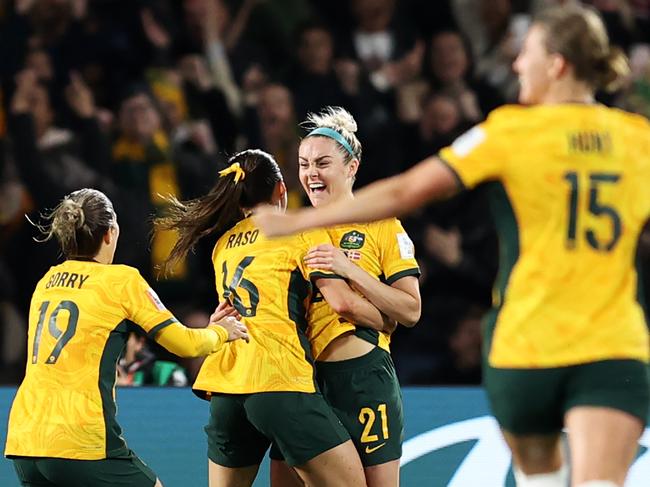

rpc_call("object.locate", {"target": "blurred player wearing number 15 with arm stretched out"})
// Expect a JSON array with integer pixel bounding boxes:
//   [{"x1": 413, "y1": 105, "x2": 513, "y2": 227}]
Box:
[{"x1": 257, "y1": 5, "x2": 650, "y2": 487}]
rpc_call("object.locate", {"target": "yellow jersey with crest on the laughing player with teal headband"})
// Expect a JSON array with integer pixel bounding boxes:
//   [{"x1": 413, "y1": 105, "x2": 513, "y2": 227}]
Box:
[{"x1": 308, "y1": 218, "x2": 420, "y2": 359}]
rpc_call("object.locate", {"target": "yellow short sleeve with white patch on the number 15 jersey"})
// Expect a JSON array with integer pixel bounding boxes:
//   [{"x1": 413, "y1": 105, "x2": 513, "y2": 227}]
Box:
[{"x1": 438, "y1": 110, "x2": 508, "y2": 188}]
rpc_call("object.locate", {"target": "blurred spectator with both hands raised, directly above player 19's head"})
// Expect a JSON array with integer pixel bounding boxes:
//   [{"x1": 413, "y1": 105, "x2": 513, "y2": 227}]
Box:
[{"x1": 6, "y1": 69, "x2": 114, "y2": 309}]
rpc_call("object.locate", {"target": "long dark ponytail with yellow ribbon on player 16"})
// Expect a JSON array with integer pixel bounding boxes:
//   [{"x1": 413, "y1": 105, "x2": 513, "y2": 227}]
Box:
[{"x1": 154, "y1": 149, "x2": 282, "y2": 273}]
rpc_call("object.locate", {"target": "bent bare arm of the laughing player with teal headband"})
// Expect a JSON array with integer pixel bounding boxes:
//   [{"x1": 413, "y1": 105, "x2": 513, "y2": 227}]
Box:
[{"x1": 305, "y1": 248, "x2": 422, "y2": 327}]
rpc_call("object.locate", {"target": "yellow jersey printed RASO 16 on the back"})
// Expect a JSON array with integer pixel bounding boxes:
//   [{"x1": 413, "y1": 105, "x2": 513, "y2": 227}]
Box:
[{"x1": 193, "y1": 218, "x2": 337, "y2": 395}]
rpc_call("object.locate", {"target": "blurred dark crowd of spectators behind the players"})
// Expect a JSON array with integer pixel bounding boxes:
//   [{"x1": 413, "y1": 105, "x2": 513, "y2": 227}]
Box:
[{"x1": 0, "y1": 0, "x2": 650, "y2": 385}]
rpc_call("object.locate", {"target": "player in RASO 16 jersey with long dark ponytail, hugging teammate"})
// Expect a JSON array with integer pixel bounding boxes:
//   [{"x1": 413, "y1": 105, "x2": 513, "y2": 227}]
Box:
[{"x1": 158, "y1": 150, "x2": 390, "y2": 487}]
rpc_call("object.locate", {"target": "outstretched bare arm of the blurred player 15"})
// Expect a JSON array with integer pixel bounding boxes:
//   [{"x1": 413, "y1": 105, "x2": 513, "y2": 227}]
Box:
[{"x1": 254, "y1": 156, "x2": 461, "y2": 236}]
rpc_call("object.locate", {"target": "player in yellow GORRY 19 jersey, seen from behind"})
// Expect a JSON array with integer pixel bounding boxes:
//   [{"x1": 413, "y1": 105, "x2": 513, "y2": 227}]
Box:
[{"x1": 5, "y1": 189, "x2": 248, "y2": 487}]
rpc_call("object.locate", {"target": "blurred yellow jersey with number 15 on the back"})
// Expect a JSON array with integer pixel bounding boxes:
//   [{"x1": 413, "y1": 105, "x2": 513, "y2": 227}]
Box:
[{"x1": 440, "y1": 104, "x2": 650, "y2": 368}]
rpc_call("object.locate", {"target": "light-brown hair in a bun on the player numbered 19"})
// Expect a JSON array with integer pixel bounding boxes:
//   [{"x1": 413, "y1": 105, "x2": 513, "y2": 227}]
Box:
[{"x1": 28, "y1": 188, "x2": 116, "y2": 258}]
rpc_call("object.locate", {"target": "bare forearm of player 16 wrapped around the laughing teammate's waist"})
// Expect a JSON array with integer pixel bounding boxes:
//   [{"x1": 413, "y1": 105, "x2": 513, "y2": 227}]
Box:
[{"x1": 315, "y1": 278, "x2": 396, "y2": 332}]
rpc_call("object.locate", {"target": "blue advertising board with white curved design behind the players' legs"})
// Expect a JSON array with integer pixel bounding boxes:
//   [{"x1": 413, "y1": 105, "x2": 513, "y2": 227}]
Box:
[{"x1": 0, "y1": 387, "x2": 650, "y2": 487}]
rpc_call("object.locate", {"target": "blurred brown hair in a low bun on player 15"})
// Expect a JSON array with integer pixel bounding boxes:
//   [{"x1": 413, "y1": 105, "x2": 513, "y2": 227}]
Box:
[{"x1": 533, "y1": 4, "x2": 630, "y2": 91}]
